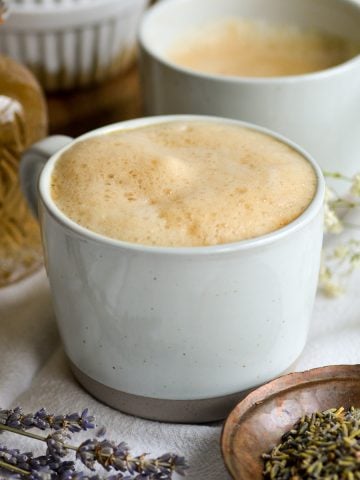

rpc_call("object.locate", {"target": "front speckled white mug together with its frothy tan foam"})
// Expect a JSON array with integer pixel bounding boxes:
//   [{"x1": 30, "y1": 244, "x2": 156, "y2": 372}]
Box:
[{"x1": 21, "y1": 116, "x2": 324, "y2": 422}]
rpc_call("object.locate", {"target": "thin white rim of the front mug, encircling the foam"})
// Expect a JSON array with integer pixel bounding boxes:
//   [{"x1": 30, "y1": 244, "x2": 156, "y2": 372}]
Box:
[{"x1": 38, "y1": 114, "x2": 325, "y2": 256}]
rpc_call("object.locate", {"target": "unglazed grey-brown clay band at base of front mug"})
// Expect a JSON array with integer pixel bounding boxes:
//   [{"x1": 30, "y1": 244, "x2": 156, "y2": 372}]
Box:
[{"x1": 68, "y1": 359, "x2": 296, "y2": 423}]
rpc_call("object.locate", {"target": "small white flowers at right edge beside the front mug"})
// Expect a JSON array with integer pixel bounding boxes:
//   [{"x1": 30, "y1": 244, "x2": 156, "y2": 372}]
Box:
[{"x1": 319, "y1": 172, "x2": 360, "y2": 297}]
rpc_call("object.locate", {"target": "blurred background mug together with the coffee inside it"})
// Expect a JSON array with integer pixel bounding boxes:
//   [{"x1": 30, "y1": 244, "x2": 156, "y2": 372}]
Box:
[{"x1": 139, "y1": 0, "x2": 360, "y2": 180}]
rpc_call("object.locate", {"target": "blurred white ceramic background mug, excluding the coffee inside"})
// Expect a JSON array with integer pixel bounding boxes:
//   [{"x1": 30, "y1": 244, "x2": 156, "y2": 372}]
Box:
[{"x1": 139, "y1": 0, "x2": 360, "y2": 175}]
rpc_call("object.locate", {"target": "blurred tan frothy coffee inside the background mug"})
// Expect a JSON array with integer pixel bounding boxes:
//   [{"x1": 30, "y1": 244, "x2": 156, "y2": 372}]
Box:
[{"x1": 168, "y1": 18, "x2": 360, "y2": 77}]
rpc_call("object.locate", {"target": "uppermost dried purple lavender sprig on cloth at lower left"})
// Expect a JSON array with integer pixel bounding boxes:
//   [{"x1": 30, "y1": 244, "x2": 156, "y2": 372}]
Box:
[{"x1": 0, "y1": 407, "x2": 95, "y2": 433}]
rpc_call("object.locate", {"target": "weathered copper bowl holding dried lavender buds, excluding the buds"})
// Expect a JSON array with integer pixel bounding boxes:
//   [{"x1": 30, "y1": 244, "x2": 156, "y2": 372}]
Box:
[{"x1": 221, "y1": 365, "x2": 360, "y2": 480}]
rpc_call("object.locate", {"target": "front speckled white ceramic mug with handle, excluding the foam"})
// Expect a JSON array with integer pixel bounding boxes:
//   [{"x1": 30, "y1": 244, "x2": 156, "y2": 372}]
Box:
[{"x1": 21, "y1": 116, "x2": 324, "y2": 422}]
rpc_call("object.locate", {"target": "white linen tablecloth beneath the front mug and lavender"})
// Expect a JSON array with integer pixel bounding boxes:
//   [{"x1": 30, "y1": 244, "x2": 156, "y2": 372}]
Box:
[{"x1": 0, "y1": 218, "x2": 360, "y2": 480}]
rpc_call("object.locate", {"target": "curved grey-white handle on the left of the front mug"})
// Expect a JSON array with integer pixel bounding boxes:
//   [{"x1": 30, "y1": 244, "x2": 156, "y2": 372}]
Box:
[{"x1": 20, "y1": 135, "x2": 74, "y2": 218}]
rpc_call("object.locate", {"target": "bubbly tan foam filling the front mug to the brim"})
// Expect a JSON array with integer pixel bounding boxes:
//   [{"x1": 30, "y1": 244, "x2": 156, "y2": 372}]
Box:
[{"x1": 51, "y1": 121, "x2": 316, "y2": 247}]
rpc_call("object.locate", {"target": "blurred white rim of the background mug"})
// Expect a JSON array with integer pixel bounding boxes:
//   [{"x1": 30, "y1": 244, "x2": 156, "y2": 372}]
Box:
[{"x1": 138, "y1": 0, "x2": 360, "y2": 85}]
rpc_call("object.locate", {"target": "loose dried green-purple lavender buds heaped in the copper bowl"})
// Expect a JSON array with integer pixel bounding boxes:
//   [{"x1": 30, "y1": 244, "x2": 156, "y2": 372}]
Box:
[{"x1": 262, "y1": 407, "x2": 360, "y2": 480}]
